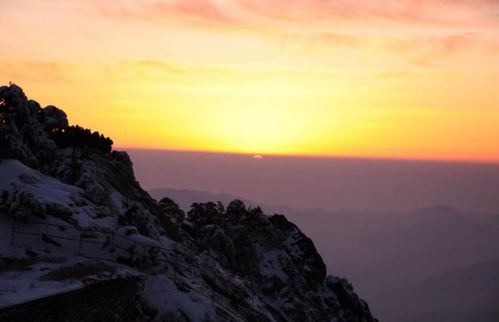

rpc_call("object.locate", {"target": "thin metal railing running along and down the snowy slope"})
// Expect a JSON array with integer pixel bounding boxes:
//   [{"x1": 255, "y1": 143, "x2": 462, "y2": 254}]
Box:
[{"x1": 11, "y1": 220, "x2": 269, "y2": 321}]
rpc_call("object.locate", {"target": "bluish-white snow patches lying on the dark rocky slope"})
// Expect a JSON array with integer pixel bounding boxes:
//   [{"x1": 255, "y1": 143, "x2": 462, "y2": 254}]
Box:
[{"x1": 0, "y1": 160, "x2": 336, "y2": 321}]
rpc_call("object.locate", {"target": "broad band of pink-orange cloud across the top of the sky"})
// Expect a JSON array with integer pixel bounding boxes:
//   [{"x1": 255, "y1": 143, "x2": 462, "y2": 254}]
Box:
[{"x1": 90, "y1": 0, "x2": 499, "y2": 65}]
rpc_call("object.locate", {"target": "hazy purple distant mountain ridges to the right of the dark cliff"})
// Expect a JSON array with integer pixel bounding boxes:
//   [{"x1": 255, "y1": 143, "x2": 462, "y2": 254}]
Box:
[{"x1": 146, "y1": 188, "x2": 499, "y2": 322}]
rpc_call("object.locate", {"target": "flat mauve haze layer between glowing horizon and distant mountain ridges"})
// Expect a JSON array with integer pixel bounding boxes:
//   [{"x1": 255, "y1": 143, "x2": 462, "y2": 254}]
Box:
[{"x1": 128, "y1": 150, "x2": 499, "y2": 213}]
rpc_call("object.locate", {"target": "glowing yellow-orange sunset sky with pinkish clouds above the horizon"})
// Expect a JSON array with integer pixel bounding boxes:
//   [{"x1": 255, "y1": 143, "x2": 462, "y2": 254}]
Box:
[{"x1": 0, "y1": 0, "x2": 499, "y2": 162}]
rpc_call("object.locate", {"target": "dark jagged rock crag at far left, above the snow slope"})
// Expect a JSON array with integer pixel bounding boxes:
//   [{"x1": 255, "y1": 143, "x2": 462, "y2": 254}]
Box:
[{"x1": 0, "y1": 84, "x2": 168, "y2": 237}]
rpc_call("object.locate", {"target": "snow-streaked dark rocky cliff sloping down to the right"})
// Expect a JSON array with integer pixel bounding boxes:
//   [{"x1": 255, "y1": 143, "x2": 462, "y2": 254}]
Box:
[{"x1": 0, "y1": 84, "x2": 374, "y2": 321}]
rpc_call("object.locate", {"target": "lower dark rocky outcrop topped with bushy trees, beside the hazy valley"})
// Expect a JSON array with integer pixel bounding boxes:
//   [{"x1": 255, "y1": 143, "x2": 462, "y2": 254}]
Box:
[{"x1": 189, "y1": 200, "x2": 373, "y2": 321}]
